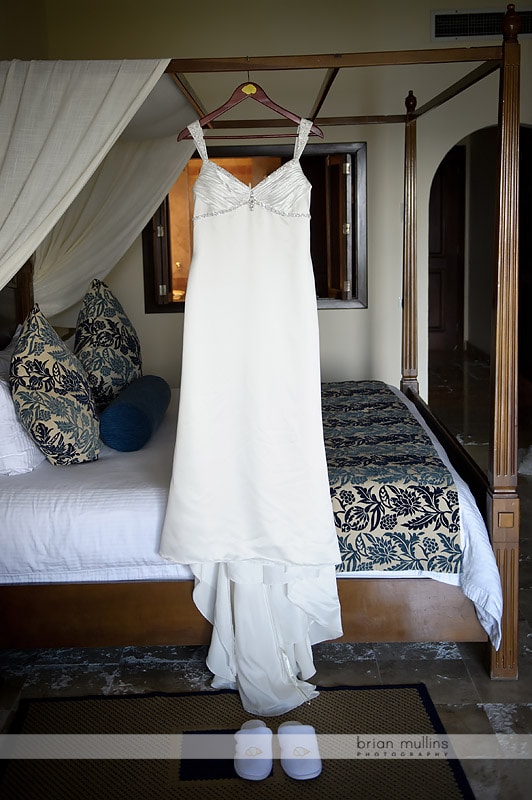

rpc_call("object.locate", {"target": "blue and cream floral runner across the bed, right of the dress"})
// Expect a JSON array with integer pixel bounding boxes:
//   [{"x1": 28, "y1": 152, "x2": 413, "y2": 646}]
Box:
[{"x1": 322, "y1": 381, "x2": 462, "y2": 573}]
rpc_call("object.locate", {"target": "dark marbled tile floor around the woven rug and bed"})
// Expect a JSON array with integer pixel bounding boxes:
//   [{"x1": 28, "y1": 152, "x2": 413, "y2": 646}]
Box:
[{"x1": 0, "y1": 359, "x2": 532, "y2": 800}]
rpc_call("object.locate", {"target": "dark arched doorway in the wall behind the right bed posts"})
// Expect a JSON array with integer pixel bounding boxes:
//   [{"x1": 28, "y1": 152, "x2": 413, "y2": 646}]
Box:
[{"x1": 428, "y1": 126, "x2": 532, "y2": 468}]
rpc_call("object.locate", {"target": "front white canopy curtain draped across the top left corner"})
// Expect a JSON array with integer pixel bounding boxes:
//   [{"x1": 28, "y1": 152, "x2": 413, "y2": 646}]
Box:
[{"x1": 0, "y1": 59, "x2": 168, "y2": 288}]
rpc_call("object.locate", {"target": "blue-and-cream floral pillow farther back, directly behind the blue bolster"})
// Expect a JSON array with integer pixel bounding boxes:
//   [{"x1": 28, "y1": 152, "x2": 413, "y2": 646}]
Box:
[{"x1": 74, "y1": 278, "x2": 142, "y2": 409}]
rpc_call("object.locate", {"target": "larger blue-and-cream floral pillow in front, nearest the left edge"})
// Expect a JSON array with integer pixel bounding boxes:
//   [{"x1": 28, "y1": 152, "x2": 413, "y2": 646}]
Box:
[{"x1": 10, "y1": 305, "x2": 101, "y2": 465}]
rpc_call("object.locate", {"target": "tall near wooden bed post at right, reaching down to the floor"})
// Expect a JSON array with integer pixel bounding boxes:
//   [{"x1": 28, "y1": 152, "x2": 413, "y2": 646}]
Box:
[{"x1": 487, "y1": 5, "x2": 520, "y2": 679}]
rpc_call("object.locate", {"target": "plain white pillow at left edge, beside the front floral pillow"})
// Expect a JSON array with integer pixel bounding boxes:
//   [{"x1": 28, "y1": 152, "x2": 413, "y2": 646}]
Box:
[{"x1": 0, "y1": 378, "x2": 44, "y2": 475}]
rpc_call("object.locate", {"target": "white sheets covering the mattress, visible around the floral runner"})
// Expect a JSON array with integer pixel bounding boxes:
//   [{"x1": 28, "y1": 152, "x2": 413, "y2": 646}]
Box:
[{"x1": 0, "y1": 387, "x2": 502, "y2": 647}]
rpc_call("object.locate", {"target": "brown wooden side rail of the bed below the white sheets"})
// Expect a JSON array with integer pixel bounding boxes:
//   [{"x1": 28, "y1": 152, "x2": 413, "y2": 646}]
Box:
[{"x1": 0, "y1": 578, "x2": 487, "y2": 648}]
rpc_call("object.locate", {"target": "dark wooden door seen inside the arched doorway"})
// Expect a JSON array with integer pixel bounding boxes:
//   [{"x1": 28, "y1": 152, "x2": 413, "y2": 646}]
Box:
[{"x1": 429, "y1": 146, "x2": 465, "y2": 351}]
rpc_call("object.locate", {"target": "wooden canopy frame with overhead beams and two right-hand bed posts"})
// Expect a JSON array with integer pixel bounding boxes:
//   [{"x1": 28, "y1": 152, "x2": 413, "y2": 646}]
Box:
[{"x1": 166, "y1": 4, "x2": 520, "y2": 678}]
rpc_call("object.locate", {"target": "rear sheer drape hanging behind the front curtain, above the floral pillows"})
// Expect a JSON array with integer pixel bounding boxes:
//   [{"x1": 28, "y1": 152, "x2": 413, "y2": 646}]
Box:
[{"x1": 34, "y1": 135, "x2": 195, "y2": 316}]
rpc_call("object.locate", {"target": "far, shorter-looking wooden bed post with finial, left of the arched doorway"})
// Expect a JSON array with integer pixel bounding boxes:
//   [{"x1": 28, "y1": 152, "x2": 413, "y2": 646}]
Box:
[{"x1": 400, "y1": 91, "x2": 419, "y2": 394}]
